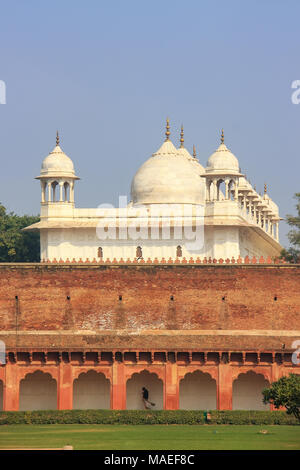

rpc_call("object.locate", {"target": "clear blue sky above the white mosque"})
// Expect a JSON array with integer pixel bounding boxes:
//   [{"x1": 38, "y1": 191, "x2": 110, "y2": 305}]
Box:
[{"x1": 0, "y1": 0, "x2": 300, "y2": 246}]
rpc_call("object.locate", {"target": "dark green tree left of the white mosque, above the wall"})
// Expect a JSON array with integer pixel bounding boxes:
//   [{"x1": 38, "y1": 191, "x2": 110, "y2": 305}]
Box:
[{"x1": 0, "y1": 204, "x2": 40, "y2": 263}]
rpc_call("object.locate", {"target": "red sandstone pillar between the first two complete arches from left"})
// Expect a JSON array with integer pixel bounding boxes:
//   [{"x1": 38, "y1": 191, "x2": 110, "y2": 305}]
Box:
[{"x1": 57, "y1": 360, "x2": 73, "y2": 410}]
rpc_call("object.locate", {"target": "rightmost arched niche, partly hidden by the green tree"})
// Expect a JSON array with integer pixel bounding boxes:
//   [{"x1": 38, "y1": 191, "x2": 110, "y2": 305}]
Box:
[{"x1": 232, "y1": 371, "x2": 270, "y2": 410}]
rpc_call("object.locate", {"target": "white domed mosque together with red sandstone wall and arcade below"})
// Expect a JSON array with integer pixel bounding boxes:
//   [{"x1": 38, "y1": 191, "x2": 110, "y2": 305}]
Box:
[{"x1": 0, "y1": 121, "x2": 300, "y2": 410}]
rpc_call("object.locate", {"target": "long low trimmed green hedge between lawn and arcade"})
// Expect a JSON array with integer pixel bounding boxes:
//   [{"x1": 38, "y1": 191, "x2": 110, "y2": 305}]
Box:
[{"x1": 0, "y1": 410, "x2": 300, "y2": 425}]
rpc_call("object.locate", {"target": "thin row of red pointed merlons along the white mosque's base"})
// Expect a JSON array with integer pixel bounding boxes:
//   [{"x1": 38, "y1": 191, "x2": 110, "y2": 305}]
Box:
[{"x1": 41, "y1": 256, "x2": 290, "y2": 265}]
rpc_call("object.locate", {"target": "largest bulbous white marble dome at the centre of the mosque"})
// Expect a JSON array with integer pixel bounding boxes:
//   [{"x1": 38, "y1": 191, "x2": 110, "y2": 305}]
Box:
[{"x1": 131, "y1": 140, "x2": 205, "y2": 204}]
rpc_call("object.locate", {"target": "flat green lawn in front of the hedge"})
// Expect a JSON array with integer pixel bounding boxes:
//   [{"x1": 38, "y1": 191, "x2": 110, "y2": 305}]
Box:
[{"x1": 0, "y1": 424, "x2": 300, "y2": 450}]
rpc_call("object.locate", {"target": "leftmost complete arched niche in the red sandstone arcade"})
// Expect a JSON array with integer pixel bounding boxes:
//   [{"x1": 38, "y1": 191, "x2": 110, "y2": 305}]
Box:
[{"x1": 19, "y1": 370, "x2": 57, "y2": 411}]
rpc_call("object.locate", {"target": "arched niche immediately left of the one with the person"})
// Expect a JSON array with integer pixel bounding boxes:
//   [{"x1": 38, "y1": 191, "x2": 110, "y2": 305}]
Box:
[{"x1": 73, "y1": 370, "x2": 110, "y2": 410}]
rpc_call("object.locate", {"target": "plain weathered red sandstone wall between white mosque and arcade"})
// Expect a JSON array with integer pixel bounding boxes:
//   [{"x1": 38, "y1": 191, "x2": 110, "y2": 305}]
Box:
[{"x1": 0, "y1": 264, "x2": 300, "y2": 331}]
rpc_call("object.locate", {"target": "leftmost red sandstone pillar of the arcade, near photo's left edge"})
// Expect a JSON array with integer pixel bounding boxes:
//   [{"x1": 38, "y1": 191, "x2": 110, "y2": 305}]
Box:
[{"x1": 3, "y1": 362, "x2": 20, "y2": 411}]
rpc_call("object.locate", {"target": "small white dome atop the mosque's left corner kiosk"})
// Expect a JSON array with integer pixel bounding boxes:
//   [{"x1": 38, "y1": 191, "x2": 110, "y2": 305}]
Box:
[{"x1": 40, "y1": 145, "x2": 75, "y2": 177}]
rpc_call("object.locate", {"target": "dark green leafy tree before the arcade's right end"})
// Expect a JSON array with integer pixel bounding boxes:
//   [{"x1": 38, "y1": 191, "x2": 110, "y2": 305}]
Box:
[{"x1": 262, "y1": 374, "x2": 300, "y2": 421}]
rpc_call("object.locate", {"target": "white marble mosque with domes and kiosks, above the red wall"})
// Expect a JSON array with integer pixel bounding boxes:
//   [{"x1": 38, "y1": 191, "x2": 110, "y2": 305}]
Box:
[{"x1": 26, "y1": 122, "x2": 281, "y2": 261}]
